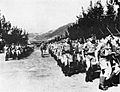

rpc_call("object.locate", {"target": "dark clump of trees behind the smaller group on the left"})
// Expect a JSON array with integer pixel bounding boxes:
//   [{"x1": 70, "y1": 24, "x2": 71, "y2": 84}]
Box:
[{"x1": 0, "y1": 15, "x2": 28, "y2": 45}]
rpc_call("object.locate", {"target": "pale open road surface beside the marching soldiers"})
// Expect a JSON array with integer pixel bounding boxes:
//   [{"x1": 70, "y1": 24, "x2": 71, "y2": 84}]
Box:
[{"x1": 0, "y1": 50, "x2": 120, "y2": 92}]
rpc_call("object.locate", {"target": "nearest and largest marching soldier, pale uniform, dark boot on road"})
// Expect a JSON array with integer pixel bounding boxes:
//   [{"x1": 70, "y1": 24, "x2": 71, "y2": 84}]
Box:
[{"x1": 95, "y1": 39, "x2": 114, "y2": 90}]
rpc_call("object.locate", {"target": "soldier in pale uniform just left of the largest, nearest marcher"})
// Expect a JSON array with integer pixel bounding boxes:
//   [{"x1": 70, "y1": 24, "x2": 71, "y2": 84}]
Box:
[{"x1": 83, "y1": 38, "x2": 97, "y2": 82}]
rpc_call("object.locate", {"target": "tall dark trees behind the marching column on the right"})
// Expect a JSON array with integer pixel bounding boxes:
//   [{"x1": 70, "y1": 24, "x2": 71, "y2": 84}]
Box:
[{"x1": 67, "y1": 0, "x2": 120, "y2": 39}]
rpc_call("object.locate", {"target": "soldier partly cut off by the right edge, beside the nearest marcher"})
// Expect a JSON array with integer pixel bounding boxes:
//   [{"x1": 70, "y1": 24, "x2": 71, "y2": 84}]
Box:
[{"x1": 110, "y1": 36, "x2": 120, "y2": 86}]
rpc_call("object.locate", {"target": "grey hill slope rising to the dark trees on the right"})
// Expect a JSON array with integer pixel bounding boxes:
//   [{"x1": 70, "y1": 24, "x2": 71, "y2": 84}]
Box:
[{"x1": 34, "y1": 23, "x2": 72, "y2": 41}]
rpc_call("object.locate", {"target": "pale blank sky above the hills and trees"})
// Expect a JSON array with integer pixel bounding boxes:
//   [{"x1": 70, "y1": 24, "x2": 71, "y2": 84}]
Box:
[{"x1": 0, "y1": 0, "x2": 105, "y2": 33}]
